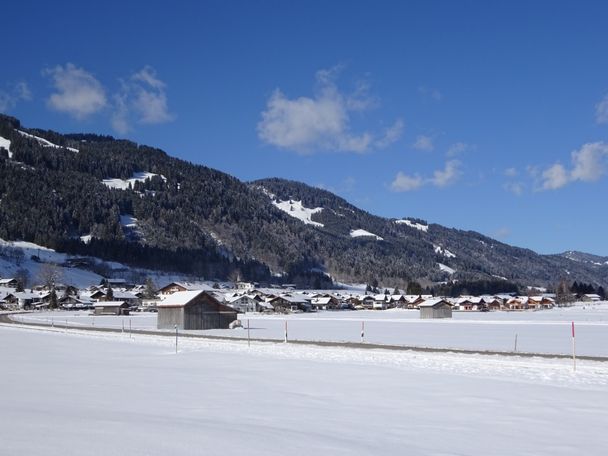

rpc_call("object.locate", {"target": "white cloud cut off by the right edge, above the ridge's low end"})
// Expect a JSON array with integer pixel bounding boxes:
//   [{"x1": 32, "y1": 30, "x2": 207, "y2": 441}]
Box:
[{"x1": 541, "y1": 142, "x2": 608, "y2": 190}]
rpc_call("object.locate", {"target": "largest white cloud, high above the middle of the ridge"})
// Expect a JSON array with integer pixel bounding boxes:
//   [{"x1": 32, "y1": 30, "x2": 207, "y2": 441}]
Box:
[{"x1": 257, "y1": 67, "x2": 403, "y2": 153}]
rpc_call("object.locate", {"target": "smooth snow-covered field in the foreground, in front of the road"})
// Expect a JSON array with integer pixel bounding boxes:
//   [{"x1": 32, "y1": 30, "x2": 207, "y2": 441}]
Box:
[{"x1": 0, "y1": 326, "x2": 608, "y2": 456}]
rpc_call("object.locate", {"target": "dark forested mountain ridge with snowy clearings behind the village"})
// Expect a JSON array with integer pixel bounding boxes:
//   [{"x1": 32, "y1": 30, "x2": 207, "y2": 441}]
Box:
[{"x1": 0, "y1": 115, "x2": 608, "y2": 286}]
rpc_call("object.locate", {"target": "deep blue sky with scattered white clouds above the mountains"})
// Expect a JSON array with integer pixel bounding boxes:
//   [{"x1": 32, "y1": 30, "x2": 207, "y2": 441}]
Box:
[{"x1": 0, "y1": 1, "x2": 608, "y2": 255}]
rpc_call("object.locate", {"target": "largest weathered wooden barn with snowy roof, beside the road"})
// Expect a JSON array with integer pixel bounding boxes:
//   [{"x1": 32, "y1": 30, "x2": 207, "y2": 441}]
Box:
[{"x1": 157, "y1": 290, "x2": 237, "y2": 330}]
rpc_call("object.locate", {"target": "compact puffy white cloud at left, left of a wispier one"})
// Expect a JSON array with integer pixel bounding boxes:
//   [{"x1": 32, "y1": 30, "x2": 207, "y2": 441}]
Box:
[{"x1": 44, "y1": 63, "x2": 107, "y2": 119}]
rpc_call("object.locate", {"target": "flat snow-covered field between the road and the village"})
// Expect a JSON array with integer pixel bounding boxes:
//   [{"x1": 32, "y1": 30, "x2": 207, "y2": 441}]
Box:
[{"x1": 18, "y1": 303, "x2": 608, "y2": 356}]
